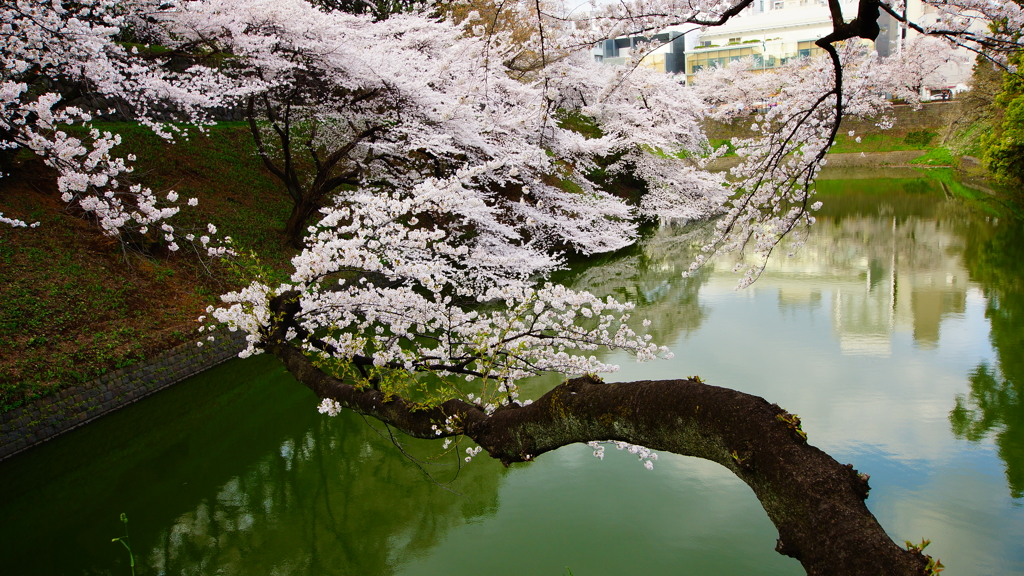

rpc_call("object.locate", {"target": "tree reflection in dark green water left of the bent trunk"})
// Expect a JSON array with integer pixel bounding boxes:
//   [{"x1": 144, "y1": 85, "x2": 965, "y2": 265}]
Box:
[{"x1": 144, "y1": 413, "x2": 502, "y2": 575}]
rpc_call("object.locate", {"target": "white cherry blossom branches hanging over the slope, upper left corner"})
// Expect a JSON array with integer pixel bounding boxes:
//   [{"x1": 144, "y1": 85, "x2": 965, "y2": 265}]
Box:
[{"x1": 0, "y1": 0, "x2": 245, "y2": 255}]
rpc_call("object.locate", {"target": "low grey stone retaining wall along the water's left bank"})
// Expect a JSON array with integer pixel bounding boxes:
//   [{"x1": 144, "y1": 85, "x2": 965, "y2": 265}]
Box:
[{"x1": 0, "y1": 332, "x2": 245, "y2": 460}]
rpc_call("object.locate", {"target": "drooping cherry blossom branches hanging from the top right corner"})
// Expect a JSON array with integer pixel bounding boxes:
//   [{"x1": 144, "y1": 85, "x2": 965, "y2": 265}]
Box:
[{"x1": 561, "y1": 0, "x2": 1024, "y2": 286}]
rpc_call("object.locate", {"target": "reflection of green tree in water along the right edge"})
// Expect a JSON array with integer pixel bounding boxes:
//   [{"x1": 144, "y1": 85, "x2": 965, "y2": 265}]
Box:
[{"x1": 949, "y1": 194, "x2": 1024, "y2": 498}]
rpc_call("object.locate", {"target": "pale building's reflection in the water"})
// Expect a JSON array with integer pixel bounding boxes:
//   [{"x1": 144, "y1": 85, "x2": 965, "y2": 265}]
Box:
[{"x1": 756, "y1": 216, "x2": 968, "y2": 356}]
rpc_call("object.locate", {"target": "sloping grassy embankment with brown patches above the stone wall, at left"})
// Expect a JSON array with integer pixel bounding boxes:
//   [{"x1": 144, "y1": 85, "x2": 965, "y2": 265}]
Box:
[{"x1": 0, "y1": 124, "x2": 291, "y2": 411}]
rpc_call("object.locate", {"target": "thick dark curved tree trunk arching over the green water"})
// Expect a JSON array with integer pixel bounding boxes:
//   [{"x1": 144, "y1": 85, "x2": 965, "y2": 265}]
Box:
[{"x1": 268, "y1": 332, "x2": 928, "y2": 576}]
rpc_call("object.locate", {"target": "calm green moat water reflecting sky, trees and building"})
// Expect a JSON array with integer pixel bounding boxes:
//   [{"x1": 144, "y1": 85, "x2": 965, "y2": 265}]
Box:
[{"x1": 0, "y1": 168, "x2": 1024, "y2": 576}]
